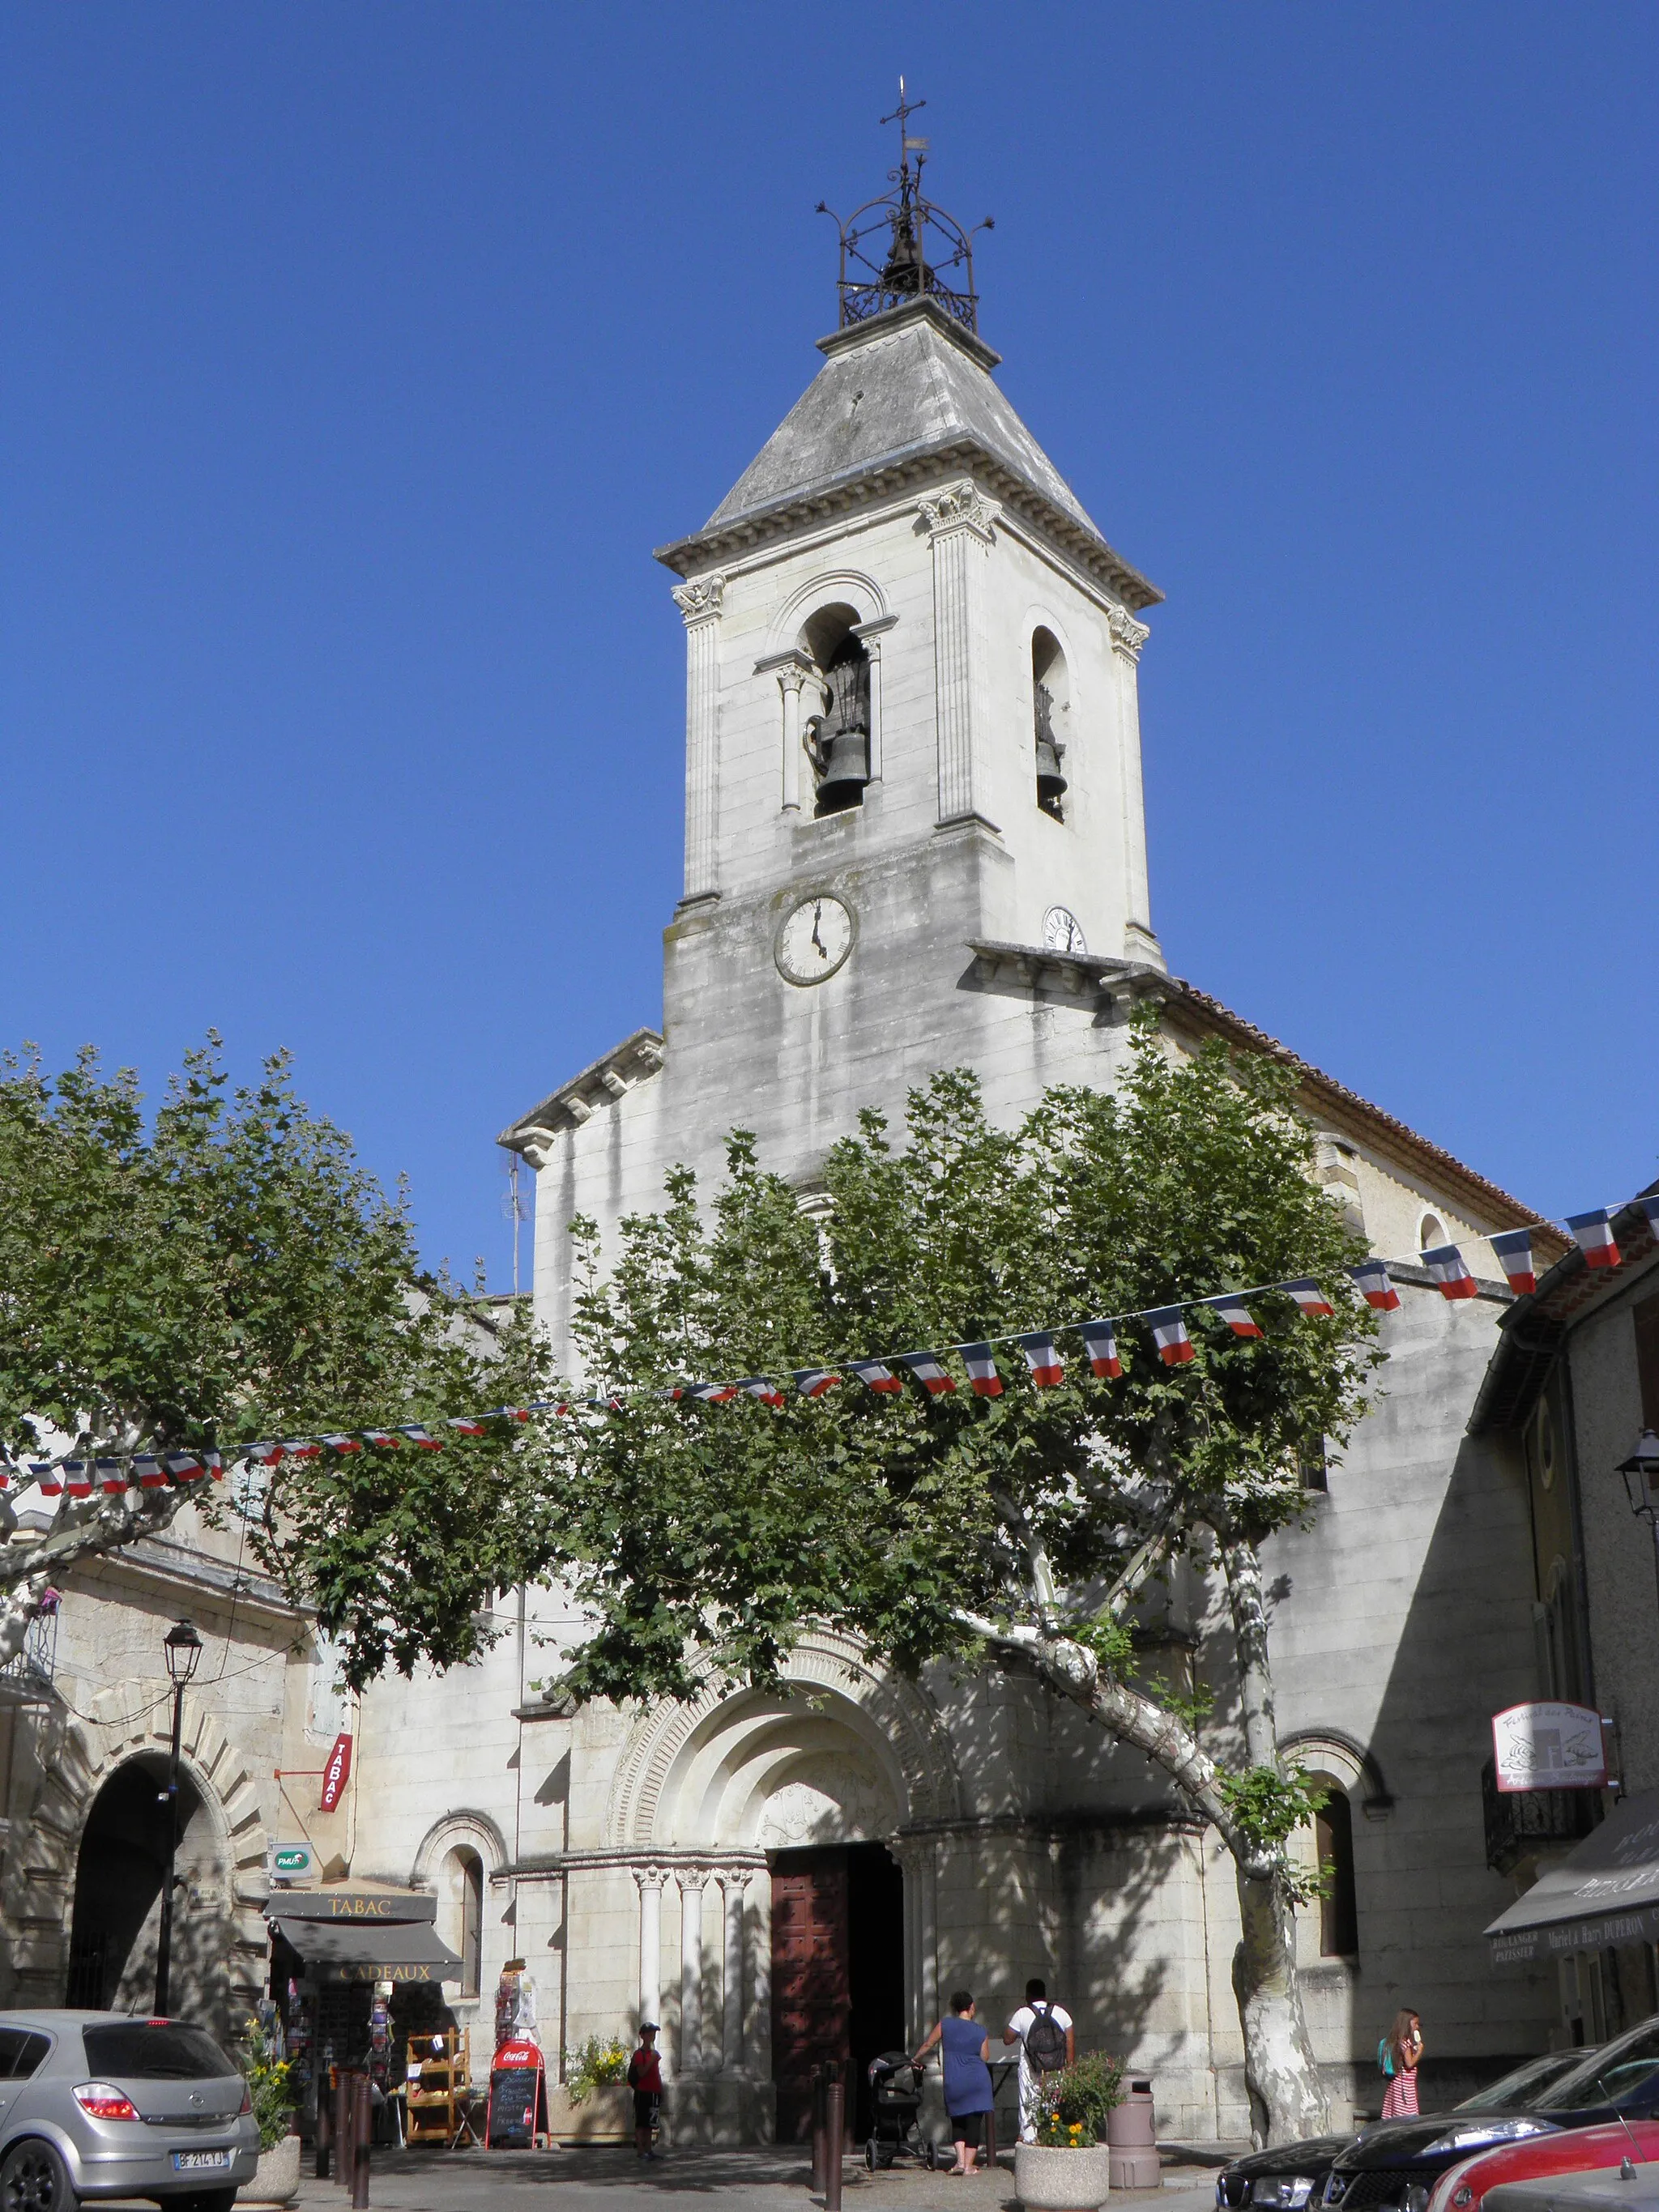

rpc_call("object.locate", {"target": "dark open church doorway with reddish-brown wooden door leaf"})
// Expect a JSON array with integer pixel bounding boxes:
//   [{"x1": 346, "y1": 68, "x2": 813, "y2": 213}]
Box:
[{"x1": 768, "y1": 1843, "x2": 905, "y2": 2143}]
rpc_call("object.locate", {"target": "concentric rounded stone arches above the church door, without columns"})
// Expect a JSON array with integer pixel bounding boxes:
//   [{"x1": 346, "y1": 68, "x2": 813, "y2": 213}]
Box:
[{"x1": 606, "y1": 1632, "x2": 957, "y2": 1852}]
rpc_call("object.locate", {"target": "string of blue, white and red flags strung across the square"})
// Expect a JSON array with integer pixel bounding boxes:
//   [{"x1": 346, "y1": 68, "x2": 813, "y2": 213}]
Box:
[{"x1": 0, "y1": 1192, "x2": 1659, "y2": 1498}]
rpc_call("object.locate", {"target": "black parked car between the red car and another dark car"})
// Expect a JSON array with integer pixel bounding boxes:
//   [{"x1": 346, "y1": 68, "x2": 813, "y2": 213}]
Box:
[{"x1": 1325, "y1": 2013, "x2": 1659, "y2": 2212}]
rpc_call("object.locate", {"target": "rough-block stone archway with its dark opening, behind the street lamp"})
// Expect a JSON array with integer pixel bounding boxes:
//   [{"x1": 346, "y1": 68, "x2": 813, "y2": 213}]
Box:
[{"x1": 0, "y1": 1679, "x2": 267, "y2": 2031}]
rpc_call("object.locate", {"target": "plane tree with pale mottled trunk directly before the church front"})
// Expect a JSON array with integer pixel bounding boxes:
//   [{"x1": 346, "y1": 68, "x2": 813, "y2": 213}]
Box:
[{"x1": 551, "y1": 1022, "x2": 1378, "y2": 2142}]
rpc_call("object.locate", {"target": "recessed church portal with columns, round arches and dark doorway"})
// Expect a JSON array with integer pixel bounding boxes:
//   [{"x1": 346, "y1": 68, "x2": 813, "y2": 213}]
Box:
[{"x1": 603, "y1": 1632, "x2": 960, "y2": 2139}]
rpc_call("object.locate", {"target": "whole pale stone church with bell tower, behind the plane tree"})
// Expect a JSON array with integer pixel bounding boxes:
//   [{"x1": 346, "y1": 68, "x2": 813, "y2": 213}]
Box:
[{"x1": 340, "y1": 242, "x2": 1559, "y2": 2139}]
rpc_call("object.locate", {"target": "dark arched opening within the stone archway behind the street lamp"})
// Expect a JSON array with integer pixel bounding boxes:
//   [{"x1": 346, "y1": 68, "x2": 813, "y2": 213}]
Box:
[{"x1": 64, "y1": 1756, "x2": 234, "y2": 2018}]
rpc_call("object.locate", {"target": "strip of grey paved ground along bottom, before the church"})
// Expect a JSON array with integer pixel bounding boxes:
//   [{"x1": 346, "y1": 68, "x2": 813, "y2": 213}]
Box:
[{"x1": 270, "y1": 2148, "x2": 1239, "y2": 2212}]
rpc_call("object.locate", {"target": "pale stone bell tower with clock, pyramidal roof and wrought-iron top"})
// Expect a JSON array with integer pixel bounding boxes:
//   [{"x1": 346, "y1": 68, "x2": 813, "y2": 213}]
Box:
[{"x1": 641, "y1": 127, "x2": 1163, "y2": 1153}]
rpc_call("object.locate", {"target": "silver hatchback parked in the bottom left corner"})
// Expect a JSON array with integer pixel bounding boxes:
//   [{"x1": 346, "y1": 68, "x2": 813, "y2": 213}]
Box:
[{"x1": 0, "y1": 2010, "x2": 258, "y2": 2212}]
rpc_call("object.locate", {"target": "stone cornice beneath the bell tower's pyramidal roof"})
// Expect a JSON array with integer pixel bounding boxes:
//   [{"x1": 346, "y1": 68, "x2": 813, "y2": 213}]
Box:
[{"x1": 657, "y1": 438, "x2": 1163, "y2": 611}]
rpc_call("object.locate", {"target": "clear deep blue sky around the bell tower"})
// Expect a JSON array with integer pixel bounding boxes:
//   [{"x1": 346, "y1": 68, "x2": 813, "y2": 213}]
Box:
[{"x1": 0, "y1": 0, "x2": 1659, "y2": 1287}]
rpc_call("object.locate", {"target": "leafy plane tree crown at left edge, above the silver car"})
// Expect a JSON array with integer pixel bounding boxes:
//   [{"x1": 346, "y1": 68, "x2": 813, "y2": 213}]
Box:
[{"x1": 0, "y1": 1040, "x2": 559, "y2": 1688}]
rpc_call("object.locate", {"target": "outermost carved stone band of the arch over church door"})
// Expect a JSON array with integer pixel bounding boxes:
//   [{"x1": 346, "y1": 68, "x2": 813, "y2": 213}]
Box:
[{"x1": 606, "y1": 1630, "x2": 957, "y2": 1865}]
